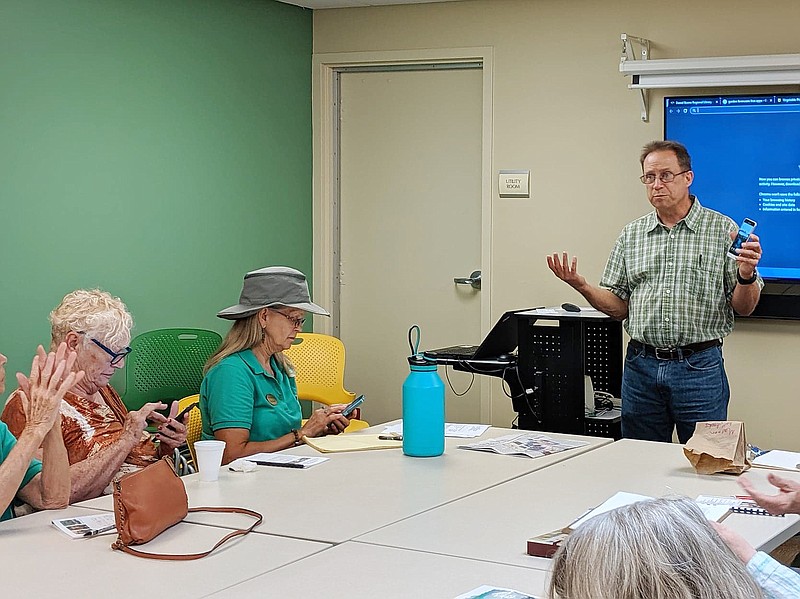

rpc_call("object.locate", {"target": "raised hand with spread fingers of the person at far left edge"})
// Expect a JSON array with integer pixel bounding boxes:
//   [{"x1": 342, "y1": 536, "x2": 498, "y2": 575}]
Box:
[{"x1": 17, "y1": 343, "x2": 84, "y2": 433}]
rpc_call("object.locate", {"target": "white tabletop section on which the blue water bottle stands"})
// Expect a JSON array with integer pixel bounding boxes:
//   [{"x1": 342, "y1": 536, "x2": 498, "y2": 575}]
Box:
[{"x1": 78, "y1": 425, "x2": 611, "y2": 543}]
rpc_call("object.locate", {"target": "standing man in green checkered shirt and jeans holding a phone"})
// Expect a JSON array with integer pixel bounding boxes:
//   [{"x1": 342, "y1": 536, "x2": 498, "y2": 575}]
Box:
[{"x1": 547, "y1": 141, "x2": 764, "y2": 443}]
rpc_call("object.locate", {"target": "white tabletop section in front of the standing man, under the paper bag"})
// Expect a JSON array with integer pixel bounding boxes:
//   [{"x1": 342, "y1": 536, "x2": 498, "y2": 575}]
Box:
[{"x1": 355, "y1": 439, "x2": 800, "y2": 570}]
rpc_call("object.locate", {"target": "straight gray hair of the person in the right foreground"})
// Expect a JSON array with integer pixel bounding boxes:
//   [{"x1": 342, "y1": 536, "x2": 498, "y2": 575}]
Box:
[{"x1": 549, "y1": 497, "x2": 764, "y2": 599}]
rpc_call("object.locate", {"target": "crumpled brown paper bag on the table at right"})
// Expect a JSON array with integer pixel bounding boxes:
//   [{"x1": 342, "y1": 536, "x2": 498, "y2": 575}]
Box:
[{"x1": 683, "y1": 420, "x2": 750, "y2": 474}]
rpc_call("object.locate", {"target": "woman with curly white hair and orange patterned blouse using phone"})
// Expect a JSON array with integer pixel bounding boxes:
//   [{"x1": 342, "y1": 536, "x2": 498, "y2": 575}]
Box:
[{"x1": 2, "y1": 289, "x2": 186, "y2": 503}]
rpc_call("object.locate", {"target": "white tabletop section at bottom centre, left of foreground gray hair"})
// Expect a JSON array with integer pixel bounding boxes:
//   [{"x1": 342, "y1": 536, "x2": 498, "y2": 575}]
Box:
[{"x1": 206, "y1": 541, "x2": 549, "y2": 599}]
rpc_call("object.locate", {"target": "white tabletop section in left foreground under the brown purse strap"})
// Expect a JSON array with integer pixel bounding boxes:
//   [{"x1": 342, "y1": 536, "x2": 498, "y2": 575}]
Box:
[{"x1": 0, "y1": 506, "x2": 330, "y2": 599}]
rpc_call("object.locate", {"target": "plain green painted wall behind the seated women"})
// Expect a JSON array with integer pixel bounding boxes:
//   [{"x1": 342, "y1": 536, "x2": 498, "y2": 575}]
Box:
[{"x1": 0, "y1": 0, "x2": 312, "y2": 404}]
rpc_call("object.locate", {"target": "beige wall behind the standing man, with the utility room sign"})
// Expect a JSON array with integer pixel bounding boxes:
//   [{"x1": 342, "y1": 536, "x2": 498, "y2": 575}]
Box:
[{"x1": 314, "y1": 0, "x2": 800, "y2": 450}]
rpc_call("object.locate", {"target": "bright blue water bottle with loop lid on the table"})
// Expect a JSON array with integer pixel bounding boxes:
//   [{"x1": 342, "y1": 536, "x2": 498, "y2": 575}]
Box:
[{"x1": 403, "y1": 325, "x2": 444, "y2": 457}]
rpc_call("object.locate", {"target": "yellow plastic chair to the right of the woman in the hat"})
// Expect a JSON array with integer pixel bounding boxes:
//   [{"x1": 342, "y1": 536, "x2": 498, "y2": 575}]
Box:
[{"x1": 284, "y1": 333, "x2": 369, "y2": 433}]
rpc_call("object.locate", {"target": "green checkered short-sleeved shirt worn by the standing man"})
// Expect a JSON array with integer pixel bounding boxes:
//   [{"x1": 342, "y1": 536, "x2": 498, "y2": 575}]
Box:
[{"x1": 600, "y1": 196, "x2": 764, "y2": 347}]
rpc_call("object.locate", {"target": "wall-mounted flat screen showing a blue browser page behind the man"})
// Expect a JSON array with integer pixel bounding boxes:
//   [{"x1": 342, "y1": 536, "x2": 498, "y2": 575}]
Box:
[{"x1": 664, "y1": 94, "x2": 800, "y2": 318}]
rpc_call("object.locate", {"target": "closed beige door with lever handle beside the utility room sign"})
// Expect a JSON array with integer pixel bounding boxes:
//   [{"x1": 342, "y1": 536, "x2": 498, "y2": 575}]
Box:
[{"x1": 339, "y1": 68, "x2": 482, "y2": 423}]
